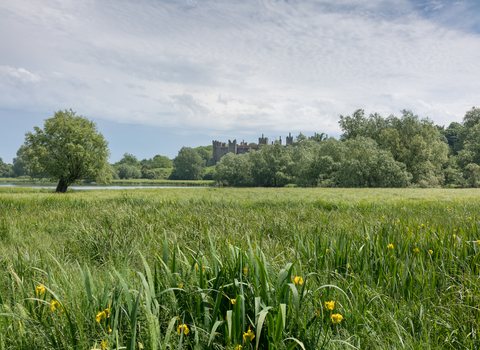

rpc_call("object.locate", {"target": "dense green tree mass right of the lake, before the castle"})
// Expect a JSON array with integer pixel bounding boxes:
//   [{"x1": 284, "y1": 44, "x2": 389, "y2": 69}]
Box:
[{"x1": 214, "y1": 107, "x2": 480, "y2": 187}]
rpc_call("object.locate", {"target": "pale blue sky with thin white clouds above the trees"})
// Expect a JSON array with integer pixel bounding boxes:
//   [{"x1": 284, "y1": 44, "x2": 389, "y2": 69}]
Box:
[{"x1": 0, "y1": 0, "x2": 480, "y2": 162}]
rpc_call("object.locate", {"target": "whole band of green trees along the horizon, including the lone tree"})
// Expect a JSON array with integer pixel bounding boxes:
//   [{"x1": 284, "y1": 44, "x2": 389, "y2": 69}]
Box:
[{"x1": 0, "y1": 107, "x2": 480, "y2": 192}]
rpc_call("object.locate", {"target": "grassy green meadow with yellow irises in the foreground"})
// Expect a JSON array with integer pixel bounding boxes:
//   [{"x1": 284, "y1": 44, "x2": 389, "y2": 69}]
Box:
[{"x1": 0, "y1": 188, "x2": 480, "y2": 350}]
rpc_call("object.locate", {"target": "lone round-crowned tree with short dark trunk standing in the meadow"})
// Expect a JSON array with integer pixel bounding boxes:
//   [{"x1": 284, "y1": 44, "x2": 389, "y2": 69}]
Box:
[{"x1": 25, "y1": 109, "x2": 111, "y2": 193}]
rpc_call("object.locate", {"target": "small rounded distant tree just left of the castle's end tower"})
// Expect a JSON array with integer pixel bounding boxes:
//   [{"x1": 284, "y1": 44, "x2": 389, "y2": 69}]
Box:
[{"x1": 169, "y1": 147, "x2": 205, "y2": 180}]
